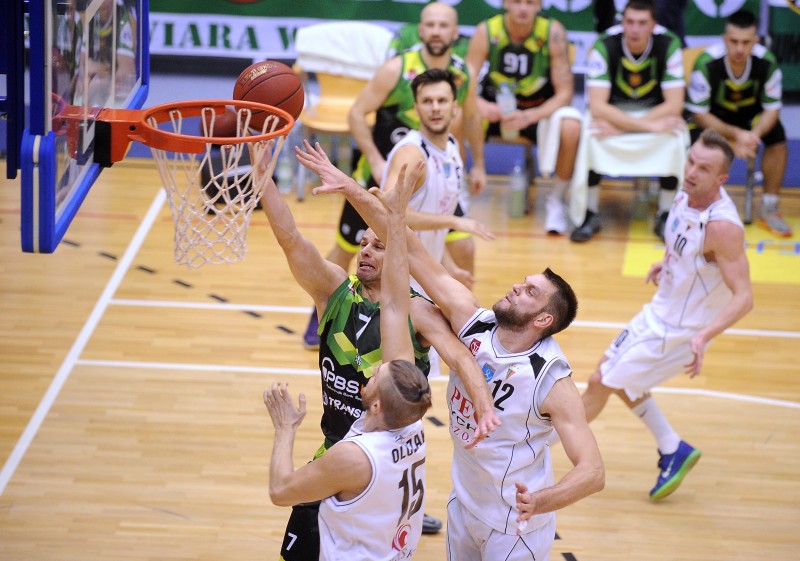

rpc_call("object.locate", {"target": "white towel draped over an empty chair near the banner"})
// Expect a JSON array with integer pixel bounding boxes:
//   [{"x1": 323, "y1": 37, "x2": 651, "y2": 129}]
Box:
[{"x1": 295, "y1": 21, "x2": 393, "y2": 80}]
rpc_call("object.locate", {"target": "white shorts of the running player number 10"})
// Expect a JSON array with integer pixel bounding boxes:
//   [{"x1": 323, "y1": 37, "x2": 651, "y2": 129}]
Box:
[{"x1": 600, "y1": 306, "x2": 697, "y2": 400}]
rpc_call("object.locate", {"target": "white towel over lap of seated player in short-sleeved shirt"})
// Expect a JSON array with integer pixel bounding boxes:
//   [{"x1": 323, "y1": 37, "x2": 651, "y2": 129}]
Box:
[{"x1": 569, "y1": 112, "x2": 690, "y2": 224}]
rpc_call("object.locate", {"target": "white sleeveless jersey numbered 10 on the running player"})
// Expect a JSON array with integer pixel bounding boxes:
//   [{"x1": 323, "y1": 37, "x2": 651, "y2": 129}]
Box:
[{"x1": 649, "y1": 188, "x2": 744, "y2": 329}]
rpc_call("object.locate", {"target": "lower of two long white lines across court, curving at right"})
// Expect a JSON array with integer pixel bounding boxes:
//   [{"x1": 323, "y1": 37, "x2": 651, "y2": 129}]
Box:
[{"x1": 76, "y1": 359, "x2": 800, "y2": 409}]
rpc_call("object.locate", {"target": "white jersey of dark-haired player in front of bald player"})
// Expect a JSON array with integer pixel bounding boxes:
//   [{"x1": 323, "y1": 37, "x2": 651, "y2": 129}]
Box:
[{"x1": 381, "y1": 130, "x2": 464, "y2": 294}]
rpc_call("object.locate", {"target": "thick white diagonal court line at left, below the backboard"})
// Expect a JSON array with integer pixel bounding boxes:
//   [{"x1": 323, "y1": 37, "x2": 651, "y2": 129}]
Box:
[{"x1": 0, "y1": 189, "x2": 166, "y2": 495}]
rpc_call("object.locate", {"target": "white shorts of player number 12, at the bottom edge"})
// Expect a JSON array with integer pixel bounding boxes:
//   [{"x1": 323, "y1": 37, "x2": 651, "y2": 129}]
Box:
[{"x1": 447, "y1": 495, "x2": 556, "y2": 561}]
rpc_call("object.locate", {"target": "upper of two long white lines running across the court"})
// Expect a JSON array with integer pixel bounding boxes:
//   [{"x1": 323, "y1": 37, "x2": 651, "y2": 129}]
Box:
[{"x1": 110, "y1": 298, "x2": 800, "y2": 339}]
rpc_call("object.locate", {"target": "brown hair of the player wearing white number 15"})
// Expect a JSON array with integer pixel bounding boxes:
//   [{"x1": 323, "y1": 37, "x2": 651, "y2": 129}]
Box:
[{"x1": 378, "y1": 359, "x2": 431, "y2": 429}]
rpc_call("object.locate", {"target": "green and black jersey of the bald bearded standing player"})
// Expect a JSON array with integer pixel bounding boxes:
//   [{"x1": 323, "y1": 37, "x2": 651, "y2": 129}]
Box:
[{"x1": 353, "y1": 50, "x2": 470, "y2": 187}]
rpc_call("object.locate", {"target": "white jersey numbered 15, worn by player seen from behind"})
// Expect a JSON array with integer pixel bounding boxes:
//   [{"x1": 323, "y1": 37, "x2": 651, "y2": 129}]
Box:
[{"x1": 319, "y1": 417, "x2": 425, "y2": 561}]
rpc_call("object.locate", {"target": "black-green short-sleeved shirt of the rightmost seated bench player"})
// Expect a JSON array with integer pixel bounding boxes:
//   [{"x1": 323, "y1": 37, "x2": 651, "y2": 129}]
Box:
[{"x1": 686, "y1": 43, "x2": 782, "y2": 126}]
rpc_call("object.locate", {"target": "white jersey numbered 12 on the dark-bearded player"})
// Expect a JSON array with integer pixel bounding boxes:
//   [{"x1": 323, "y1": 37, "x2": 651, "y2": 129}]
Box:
[{"x1": 447, "y1": 308, "x2": 572, "y2": 534}]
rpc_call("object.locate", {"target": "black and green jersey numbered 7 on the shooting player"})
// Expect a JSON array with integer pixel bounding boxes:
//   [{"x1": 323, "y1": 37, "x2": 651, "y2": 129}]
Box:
[{"x1": 319, "y1": 275, "x2": 430, "y2": 443}]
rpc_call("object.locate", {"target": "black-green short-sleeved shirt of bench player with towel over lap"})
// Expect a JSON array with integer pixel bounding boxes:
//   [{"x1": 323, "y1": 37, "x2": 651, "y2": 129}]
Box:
[{"x1": 586, "y1": 25, "x2": 684, "y2": 111}]
